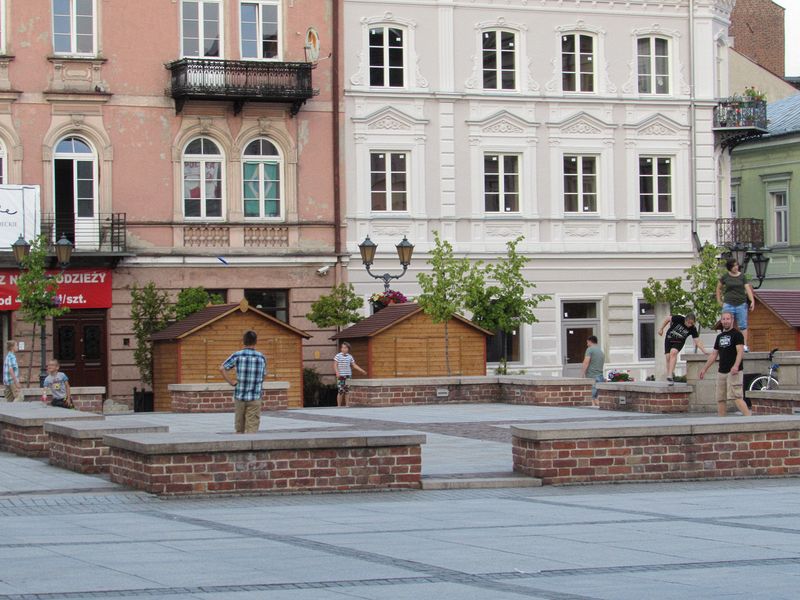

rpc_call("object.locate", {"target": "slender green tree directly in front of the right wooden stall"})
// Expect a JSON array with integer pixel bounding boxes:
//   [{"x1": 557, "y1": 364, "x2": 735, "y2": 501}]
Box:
[{"x1": 417, "y1": 231, "x2": 483, "y2": 376}]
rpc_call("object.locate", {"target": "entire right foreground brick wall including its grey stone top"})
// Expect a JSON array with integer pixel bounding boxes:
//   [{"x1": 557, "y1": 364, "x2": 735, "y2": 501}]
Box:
[{"x1": 511, "y1": 416, "x2": 800, "y2": 484}]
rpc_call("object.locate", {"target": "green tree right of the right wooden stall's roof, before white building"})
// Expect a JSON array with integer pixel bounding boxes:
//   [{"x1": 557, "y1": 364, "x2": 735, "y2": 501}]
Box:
[{"x1": 467, "y1": 236, "x2": 550, "y2": 375}]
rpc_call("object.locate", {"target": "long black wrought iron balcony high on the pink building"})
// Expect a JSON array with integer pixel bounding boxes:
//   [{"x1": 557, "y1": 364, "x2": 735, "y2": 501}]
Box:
[{"x1": 167, "y1": 58, "x2": 315, "y2": 115}]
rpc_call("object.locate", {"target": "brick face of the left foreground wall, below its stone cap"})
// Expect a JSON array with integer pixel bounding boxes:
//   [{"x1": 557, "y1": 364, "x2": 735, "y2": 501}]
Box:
[{"x1": 110, "y1": 445, "x2": 422, "y2": 495}]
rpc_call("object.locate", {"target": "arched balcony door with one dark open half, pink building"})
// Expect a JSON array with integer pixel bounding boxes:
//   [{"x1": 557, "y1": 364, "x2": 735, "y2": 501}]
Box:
[{"x1": 52, "y1": 136, "x2": 99, "y2": 250}]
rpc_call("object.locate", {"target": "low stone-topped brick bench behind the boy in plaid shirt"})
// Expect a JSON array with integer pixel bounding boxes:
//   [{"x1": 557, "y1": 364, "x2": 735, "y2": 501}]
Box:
[{"x1": 167, "y1": 381, "x2": 289, "y2": 413}]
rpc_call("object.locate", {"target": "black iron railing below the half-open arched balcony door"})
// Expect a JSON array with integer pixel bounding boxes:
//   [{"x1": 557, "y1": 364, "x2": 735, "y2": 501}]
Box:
[{"x1": 42, "y1": 213, "x2": 128, "y2": 253}]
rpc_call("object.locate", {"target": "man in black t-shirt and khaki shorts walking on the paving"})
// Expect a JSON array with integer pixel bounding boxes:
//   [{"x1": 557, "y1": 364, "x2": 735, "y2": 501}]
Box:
[{"x1": 700, "y1": 311, "x2": 751, "y2": 417}]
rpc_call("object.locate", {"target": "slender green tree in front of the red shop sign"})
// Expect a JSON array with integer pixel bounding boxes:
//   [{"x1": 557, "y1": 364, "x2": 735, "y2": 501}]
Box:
[{"x1": 17, "y1": 235, "x2": 69, "y2": 383}]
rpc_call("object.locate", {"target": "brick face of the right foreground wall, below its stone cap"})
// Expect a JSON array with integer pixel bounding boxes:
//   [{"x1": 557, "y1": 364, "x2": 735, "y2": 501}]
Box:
[{"x1": 513, "y1": 431, "x2": 800, "y2": 485}]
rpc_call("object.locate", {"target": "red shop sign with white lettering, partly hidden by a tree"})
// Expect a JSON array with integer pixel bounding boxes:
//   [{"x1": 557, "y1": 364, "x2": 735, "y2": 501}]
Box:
[{"x1": 0, "y1": 269, "x2": 111, "y2": 310}]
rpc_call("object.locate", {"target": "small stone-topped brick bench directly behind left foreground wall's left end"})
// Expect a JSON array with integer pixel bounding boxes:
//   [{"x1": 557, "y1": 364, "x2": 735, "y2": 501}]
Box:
[{"x1": 44, "y1": 419, "x2": 169, "y2": 473}]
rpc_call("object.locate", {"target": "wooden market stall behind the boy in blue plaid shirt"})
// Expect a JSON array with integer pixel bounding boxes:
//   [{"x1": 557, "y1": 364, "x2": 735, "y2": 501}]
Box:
[{"x1": 150, "y1": 300, "x2": 311, "y2": 411}]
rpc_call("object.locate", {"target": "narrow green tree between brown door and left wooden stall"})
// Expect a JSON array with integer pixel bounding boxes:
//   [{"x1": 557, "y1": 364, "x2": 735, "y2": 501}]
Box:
[{"x1": 131, "y1": 281, "x2": 174, "y2": 385}]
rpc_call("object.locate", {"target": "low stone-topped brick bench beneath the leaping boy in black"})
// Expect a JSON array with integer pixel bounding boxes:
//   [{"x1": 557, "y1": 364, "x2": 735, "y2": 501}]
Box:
[{"x1": 597, "y1": 381, "x2": 692, "y2": 413}]
